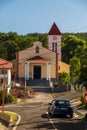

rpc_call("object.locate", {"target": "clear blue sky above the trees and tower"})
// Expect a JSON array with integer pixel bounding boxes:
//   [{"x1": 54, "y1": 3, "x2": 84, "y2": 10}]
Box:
[{"x1": 0, "y1": 0, "x2": 87, "y2": 35}]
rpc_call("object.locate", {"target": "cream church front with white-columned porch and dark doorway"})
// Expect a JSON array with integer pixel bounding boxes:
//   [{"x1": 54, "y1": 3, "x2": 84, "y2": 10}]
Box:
[{"x1": 17, "y1": 41, "x2": 56, "y2": 80}]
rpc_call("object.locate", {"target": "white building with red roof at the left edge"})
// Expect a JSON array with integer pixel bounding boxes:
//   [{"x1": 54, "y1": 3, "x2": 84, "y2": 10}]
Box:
[{"x1": 0, "y1": 58, "x2": 12, "y2": 86}]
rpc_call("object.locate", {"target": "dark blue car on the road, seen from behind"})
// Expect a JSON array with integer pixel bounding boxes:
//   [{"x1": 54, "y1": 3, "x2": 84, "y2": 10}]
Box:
[{"x1": 48, "y1": 98, "x2": 73, "y2": 118}]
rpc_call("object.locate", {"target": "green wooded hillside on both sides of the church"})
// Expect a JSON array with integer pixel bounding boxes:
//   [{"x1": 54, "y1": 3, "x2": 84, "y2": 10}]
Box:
[{"x1": 0, "y1": 32, "x2": 87, "y2": 82}]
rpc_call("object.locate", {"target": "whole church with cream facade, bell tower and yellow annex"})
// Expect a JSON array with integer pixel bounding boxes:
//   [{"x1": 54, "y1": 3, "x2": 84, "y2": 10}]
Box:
[{"x1": 16, "y1": 23, "x2": 69, "y2": 85}]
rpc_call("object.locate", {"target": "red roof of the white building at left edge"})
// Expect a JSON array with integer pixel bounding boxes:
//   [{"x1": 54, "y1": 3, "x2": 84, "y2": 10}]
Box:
[{"x1": 0, "y1": 58, "x2": 12, "y2": 69}]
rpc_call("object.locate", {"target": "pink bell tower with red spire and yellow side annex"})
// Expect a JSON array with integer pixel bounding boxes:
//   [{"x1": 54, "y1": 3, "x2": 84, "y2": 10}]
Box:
[{"x1": 48, "y1": 23, "x2": 70, "y2": 74}]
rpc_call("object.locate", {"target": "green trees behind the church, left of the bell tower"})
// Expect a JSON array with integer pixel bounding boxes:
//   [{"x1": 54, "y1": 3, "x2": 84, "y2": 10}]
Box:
[{"x1": 0, "y1": 32, "x2": 47, "y2": 61}]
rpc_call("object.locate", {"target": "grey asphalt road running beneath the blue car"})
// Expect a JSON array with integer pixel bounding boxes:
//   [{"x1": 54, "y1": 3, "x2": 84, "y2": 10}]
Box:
[{"x1": 5, "y1": 93, "x2": 87, "y2": 130}]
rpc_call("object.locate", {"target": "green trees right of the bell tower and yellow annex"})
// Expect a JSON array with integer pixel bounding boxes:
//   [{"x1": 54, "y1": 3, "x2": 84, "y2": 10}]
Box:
[{"x1": 62, "y1": 34, "x2": 87, "y2": 84}]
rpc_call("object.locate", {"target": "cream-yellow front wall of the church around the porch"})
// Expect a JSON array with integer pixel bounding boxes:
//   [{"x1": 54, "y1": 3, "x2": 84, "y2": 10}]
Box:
[{"x1": 18, "y1": 41, "x2": 56, "y2": 78}]
